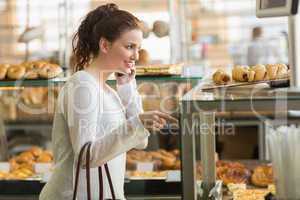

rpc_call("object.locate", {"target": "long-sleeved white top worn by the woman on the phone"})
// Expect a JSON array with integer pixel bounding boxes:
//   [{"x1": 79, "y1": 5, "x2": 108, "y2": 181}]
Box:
[{"x1": 40, "y1": 71, "x2": 149, "y2": 200}]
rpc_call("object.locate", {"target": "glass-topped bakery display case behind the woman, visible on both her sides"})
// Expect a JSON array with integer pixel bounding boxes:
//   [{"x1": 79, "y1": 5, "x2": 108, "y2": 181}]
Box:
[{"x1": 0, "y1": 76, "x2": 200, "y2": 199}]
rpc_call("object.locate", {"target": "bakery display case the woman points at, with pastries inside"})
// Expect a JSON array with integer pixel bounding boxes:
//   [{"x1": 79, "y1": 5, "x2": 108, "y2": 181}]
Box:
[{"x1": 180, "y1": 83, "x2": 300, "y2": 200}]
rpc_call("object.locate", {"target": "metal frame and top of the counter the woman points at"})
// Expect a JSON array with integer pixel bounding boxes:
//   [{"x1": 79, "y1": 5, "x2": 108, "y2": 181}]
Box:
[{"x1": 180, "y1": 84, "x2": 300, "y2": 200}]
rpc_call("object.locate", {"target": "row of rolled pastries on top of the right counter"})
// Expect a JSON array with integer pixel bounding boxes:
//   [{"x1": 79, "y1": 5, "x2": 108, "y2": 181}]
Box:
[{"x1": 212, "y1": 64, "x2": 289, "y2": 85}]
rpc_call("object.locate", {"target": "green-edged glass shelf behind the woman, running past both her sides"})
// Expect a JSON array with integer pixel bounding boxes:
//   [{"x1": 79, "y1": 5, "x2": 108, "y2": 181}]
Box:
[{"x1": 0, "y1": 76, "x2": 201, "y2": 88}]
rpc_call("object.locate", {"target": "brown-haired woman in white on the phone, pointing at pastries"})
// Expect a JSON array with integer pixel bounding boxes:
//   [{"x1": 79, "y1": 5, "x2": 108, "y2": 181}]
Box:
[{"x1": 40, "y1": 4, "x2": 176, "y2": 200}]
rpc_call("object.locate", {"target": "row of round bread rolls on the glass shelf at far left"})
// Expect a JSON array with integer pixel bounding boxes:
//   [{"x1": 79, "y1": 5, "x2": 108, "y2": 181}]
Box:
[{"x1": 0, "y1": 61, "x2": 63, "y2": 80}]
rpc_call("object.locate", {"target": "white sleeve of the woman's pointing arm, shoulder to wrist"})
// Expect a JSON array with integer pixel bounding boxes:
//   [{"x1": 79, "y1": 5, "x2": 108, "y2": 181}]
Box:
[{"x1": 64, "y1": 76, "x2": 149, "y2": 167}]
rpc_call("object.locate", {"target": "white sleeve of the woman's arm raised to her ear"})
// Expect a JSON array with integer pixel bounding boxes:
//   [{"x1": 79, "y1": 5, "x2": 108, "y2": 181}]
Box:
[{"x1": 117, "y1": 79, "x2": 148, "y2": 149}]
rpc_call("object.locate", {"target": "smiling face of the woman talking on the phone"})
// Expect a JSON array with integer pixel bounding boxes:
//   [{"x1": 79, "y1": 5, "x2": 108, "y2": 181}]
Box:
[{"x1": 100, "y1": 29, "x2": 143, "y2": 74}]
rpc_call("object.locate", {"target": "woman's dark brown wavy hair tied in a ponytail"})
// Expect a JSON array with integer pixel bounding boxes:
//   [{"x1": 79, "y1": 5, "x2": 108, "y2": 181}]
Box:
[{"x1": 72, "y1": 3, "x2": 141, "y2": 71}]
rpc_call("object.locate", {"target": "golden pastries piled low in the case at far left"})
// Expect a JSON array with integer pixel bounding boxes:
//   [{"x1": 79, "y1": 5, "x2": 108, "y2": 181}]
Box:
[{"x1": 0, "y1": 146, "x2": 53, "y2": 180}]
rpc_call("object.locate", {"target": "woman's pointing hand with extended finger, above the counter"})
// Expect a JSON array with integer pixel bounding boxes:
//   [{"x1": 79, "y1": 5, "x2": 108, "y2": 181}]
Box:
[{"x1": 139, "y1": 111, "x2": 178, "y2": 132}]
